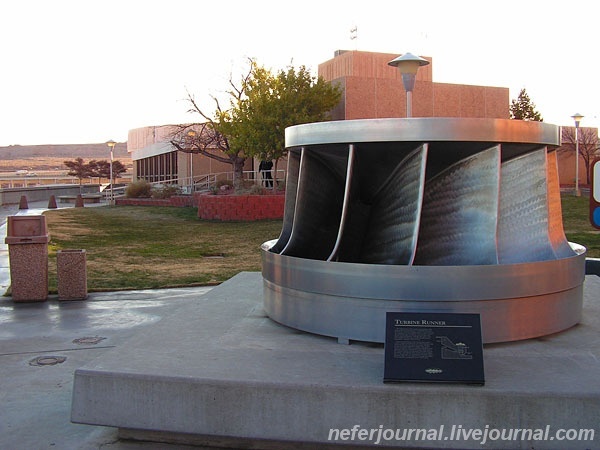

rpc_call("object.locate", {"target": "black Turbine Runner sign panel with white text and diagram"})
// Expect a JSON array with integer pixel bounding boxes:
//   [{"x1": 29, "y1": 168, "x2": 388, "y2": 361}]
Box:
[{"x1": 383, "y1": 312, "x2": 485, "y2": 384}]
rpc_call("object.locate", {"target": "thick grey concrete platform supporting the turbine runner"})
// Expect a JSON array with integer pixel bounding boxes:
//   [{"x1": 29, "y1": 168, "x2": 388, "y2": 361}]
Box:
[{"x1": 71, "y1": 273, "x2": 600, "y2": 449}]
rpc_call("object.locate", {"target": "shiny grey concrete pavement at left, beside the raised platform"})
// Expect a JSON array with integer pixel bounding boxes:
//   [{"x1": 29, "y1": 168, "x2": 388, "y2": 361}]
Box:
[{"x1": 0, "y1": 202, "x2": 216, "y2": 450}]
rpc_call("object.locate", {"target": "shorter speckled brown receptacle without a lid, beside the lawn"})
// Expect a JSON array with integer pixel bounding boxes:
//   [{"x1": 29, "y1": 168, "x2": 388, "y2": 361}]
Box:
[{"x1": 56, "y1": 250, "x2": 87, "y2": 300}]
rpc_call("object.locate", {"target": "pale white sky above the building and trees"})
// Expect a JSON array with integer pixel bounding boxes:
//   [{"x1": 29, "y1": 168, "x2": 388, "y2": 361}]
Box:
[{"x1": 0, "y1": 0, "x2": 600, "y2": 146}]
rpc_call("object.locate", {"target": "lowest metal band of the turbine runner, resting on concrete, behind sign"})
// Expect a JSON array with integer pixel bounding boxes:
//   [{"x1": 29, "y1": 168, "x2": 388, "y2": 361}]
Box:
[{"x1": 264, "y1": 280, "x2": 583, "y2": 344}]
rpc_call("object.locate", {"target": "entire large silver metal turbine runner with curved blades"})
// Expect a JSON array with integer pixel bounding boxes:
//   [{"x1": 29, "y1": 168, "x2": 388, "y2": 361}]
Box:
[{"x1": 262, "y1": 118, "x2": 585, "y2": 343}]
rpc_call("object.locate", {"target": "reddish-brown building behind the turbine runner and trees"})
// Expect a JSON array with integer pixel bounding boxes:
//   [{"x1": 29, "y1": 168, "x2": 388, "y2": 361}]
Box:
[{"x1": 127, "y1": 50, "x2": 597, "y2": 190}]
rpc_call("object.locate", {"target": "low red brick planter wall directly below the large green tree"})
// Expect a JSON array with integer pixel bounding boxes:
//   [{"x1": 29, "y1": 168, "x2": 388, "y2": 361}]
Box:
[{"x1": 194, "y1": 194, "x2": 285, "y2": 221}]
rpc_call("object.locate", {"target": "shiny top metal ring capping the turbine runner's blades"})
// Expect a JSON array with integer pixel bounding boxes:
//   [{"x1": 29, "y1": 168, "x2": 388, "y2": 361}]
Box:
[{"x1": 285, "y1": 117, "x2": 560, "y2": 148}]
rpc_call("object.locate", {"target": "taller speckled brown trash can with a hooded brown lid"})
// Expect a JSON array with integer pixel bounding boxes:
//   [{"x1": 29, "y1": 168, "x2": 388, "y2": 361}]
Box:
[{"x1": 5, "y1": 215, "x2": 49, "y2": 302}]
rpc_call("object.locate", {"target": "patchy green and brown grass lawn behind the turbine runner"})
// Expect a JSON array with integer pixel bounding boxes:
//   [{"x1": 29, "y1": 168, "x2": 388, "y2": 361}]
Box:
[{"x1": 45, "y1": 194, "x2": 600, "y2": 292}]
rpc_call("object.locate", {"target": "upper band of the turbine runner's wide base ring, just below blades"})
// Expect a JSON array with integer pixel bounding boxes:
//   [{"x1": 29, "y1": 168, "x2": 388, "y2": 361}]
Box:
[{"x1": 261, "y1": 241, "x2": 586, "y2": 302}]
